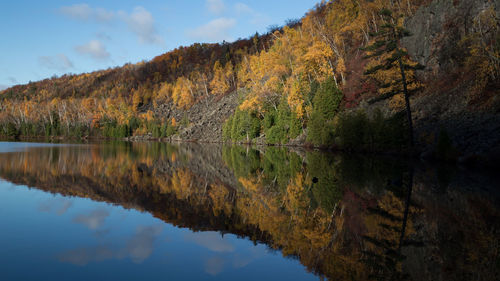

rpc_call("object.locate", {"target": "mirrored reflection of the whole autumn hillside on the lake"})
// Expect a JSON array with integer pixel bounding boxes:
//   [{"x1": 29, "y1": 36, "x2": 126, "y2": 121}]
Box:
[{"x1": 0, "y1": 143, "x2": 500, "y2": 280}]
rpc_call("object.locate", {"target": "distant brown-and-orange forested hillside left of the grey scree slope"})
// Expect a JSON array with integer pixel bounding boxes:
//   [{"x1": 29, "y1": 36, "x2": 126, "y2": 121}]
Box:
[{"x1": 0, "y1": 34, "x2": 271, "y2": 137}]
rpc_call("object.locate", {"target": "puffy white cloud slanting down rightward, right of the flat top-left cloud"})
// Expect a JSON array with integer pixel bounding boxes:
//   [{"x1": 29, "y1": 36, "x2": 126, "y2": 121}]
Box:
[{"x1": 118, "y1": 6, "x2": 164, "y2": 45}]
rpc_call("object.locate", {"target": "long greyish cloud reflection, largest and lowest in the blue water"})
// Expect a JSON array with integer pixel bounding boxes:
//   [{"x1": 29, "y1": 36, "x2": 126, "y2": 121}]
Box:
[{"x1": 59, "y1": 225, "x2": 163, "y2": 266}]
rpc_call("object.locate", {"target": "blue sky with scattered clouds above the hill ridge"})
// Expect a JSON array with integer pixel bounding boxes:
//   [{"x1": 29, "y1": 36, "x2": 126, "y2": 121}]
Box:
[{"x1": 0, "y1": 0, "x2": 319, "y2": 89}]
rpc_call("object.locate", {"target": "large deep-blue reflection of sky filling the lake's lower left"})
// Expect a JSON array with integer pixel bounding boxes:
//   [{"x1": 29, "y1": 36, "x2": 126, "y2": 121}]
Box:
[{"x1": 0, "y1": 180, "x2": 317, "y2": 280}]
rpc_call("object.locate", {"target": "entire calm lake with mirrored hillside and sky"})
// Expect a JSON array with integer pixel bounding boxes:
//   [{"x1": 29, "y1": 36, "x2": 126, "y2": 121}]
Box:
[{"x1": 0, "y1": 142, "x2": 500, "y2": 280}]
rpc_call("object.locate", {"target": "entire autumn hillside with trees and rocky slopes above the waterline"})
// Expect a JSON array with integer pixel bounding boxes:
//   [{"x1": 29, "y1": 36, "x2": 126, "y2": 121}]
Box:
[{"x1": 0, "y1": 0, "x2": 500, "y2": 159}]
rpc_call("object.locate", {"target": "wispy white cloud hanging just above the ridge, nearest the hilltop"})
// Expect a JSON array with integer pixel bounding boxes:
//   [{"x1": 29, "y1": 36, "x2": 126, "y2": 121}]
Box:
[{"x1": 188, "y1": 18, "x2": 236, "y2": 42}]
